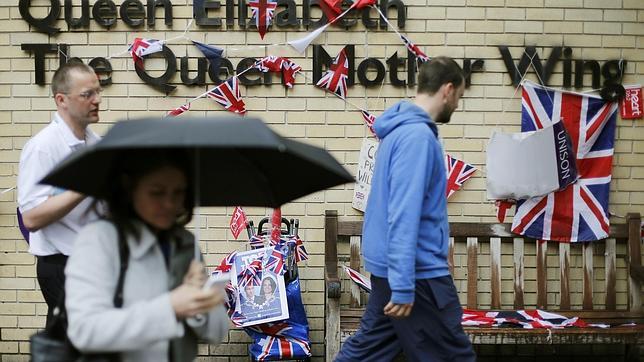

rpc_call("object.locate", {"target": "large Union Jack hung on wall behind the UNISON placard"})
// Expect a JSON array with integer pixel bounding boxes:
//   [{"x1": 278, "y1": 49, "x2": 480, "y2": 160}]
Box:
[{"x1": 512, "y1": 82, "x2": 617, "y2": 242}]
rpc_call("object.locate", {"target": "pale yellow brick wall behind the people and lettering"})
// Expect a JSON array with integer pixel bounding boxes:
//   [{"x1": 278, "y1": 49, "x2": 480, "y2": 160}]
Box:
[{"x1": 0, "y1": 0, "x2": 644, "y2": 362}]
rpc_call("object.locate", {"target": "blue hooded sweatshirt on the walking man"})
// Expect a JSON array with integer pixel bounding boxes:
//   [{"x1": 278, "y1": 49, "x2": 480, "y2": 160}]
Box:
[{"x1": 362, "y1": 101, "x2": 449, "y2": 304}]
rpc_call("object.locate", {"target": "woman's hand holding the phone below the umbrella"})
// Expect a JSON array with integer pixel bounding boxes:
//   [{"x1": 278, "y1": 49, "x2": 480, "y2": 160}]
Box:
[{"x1": 170, "y1": 283, "x2": 224, "y2": 319}]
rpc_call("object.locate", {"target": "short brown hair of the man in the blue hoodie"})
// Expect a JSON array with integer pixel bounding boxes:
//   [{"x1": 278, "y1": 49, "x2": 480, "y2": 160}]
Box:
[{"x1": 418, "y1": 57, "x2": 465, "y2": 95}]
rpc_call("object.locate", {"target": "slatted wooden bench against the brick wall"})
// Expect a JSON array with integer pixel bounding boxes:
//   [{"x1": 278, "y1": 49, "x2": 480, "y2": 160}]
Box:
[{"x1": 325, "y1": 210, "x2": 644, "y2": 361}]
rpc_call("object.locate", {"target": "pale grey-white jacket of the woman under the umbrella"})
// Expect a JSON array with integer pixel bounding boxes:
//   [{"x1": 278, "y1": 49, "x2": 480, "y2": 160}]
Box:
[{"x1": 65, "y1": 220, "x2": 229, "y2": 362}]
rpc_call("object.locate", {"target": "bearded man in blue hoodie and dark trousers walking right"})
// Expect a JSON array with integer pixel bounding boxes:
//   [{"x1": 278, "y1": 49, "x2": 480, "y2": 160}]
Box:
[{"x1": 336, "y1": 57, "x2": 476, "y2": 362}]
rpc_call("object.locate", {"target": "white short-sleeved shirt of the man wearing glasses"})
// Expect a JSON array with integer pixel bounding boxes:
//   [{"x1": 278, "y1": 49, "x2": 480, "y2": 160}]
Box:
[{"x1": 18, "y1": 113, "x2": 99, "y2": 256}]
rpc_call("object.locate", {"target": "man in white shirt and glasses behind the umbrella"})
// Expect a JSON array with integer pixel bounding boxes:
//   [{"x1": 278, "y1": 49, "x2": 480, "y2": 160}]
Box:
[{"x1": 18, "y1": 62, "x2": 102, "y2": 323}]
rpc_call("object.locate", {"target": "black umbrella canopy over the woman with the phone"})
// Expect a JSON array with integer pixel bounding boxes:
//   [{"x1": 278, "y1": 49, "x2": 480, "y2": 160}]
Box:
[{"x1": 42, "y1": 116, "x2": 354, "y2": 207}]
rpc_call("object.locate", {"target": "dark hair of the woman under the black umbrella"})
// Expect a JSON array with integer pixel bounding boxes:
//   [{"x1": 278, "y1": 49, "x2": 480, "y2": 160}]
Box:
[{"x1": 104, "y1": 149, "x2": 195, "y2": 238}]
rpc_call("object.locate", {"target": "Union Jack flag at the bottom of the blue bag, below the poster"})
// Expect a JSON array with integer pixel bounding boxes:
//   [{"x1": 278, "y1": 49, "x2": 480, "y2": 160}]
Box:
[{"x1": 248, "y1": 322, "x2": 311, "y2": 361}]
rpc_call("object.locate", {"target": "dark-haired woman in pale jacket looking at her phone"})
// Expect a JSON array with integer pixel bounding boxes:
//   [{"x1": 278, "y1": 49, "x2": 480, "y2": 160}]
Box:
[{"x1": 65, "y1": 150, "x2": 229, "y2": 361}]
